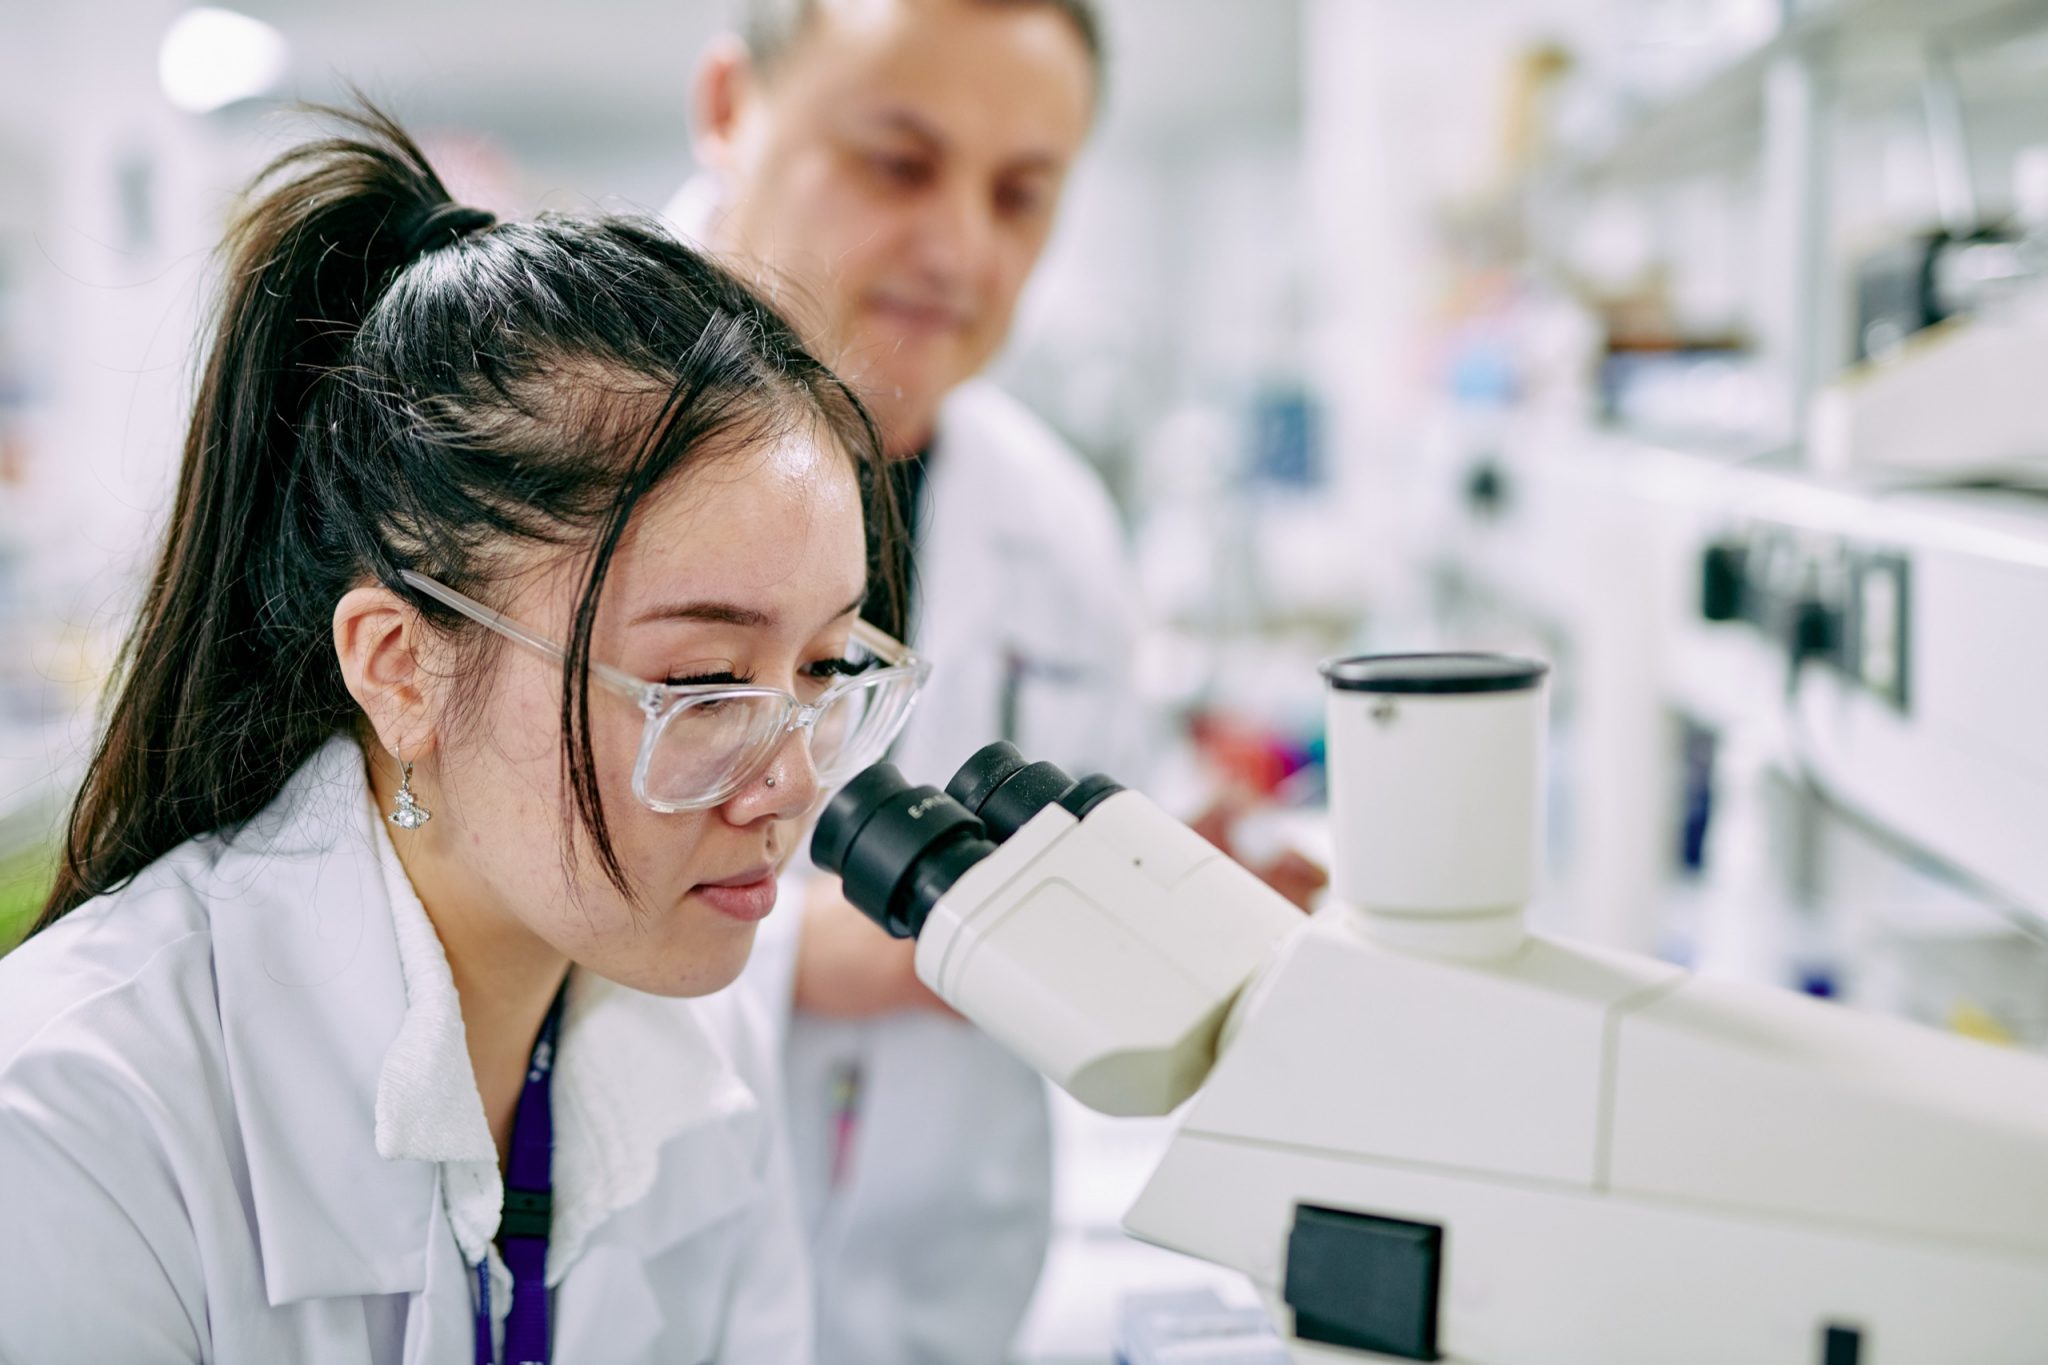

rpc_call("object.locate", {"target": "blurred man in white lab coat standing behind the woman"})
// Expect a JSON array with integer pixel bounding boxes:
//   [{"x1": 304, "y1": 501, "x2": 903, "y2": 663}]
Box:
[{"x1": 670, "y1": 0, "x2": 1318, "y2": 1365}]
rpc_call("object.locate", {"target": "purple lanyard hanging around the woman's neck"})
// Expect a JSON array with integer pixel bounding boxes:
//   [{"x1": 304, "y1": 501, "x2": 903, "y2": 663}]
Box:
[{"x1": 477, "y1": 982, "x2": 569, "y2": 1365}]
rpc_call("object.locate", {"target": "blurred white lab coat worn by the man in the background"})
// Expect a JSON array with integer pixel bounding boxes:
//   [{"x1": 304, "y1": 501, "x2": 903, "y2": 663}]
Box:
[{"x1": 741, "y1": 381, "x2": 1147, "y2": 1365}]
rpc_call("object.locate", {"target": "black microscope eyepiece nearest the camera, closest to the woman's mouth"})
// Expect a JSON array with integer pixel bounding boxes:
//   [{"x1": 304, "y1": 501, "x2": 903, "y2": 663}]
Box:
[{"x1": 811, "y1": 763, "x2": 995, "y2": 939}]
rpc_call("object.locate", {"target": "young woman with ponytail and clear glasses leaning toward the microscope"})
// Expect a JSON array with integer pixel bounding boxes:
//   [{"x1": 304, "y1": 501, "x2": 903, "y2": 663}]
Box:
[{"x1": 0, "y1": 113, "x2": 924, "y2": 1365}]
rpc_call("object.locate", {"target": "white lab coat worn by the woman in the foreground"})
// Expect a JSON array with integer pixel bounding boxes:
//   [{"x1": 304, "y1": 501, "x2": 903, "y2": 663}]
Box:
[{"x1": 0, "y1": 739, "x2": 811, "y2": 1365}]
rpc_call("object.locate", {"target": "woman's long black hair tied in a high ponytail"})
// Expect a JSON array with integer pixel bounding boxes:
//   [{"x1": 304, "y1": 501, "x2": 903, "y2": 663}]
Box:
[{"x1": 37, "y1": 104, "x2": 895, "y2": 927}]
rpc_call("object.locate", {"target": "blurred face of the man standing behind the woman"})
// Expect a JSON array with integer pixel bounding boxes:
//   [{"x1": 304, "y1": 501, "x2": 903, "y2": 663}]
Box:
[{"x1": 698, "y1": 0, "x2": 1094, "y2": 452}]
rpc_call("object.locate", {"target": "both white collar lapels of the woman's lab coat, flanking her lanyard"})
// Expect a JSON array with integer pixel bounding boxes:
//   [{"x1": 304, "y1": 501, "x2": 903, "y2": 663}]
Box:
[{"x1": 213, "y1": 737, "x2": 764, "y2": 1340}]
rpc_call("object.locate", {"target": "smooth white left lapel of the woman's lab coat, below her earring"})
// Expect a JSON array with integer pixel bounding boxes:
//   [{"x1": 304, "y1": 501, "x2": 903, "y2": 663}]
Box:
[{"x1": 209, "y1": 737, "x2": 434, "y2": 1308}]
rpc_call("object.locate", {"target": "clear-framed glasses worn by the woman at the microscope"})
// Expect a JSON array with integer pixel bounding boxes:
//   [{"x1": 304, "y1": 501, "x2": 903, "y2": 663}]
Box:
[{"x1": 399, "y1": 569, "x2": 932, "y2": 812}]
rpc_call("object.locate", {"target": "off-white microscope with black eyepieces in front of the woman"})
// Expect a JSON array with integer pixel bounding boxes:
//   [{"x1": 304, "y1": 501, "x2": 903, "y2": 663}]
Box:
[{"x1": 811, "y1": 655, "x2": 2048, "y2": 1365}]
